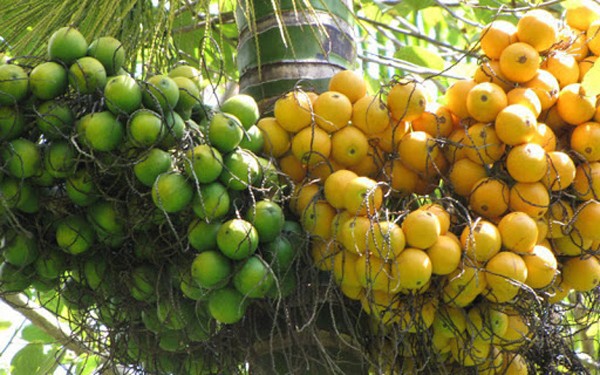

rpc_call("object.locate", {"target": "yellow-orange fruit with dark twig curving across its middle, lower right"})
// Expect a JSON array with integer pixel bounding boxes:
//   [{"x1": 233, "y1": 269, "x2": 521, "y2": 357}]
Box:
[{"x1": 485, "y1": 251, "x2": 527, "y2": 303}]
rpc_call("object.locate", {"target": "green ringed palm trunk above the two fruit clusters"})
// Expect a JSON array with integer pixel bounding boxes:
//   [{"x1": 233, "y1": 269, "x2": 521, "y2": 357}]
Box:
[{"x1": 236, "y1": 0, "x2": 356, "y2": 109}]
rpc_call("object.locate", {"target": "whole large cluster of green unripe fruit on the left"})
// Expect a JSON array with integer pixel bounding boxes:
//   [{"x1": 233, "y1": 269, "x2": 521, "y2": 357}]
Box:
[{"x1": 0, "y1": 27, "x2": 301, "y2": 373}]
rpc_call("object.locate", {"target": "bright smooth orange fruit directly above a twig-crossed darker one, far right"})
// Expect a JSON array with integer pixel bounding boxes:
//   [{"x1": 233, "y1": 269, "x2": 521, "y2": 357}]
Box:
[{"x1": 506, "y1": 143, "x2": 548, "y2": 182}]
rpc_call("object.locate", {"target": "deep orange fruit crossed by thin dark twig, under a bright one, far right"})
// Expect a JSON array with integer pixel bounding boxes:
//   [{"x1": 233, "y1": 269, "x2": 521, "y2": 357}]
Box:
[{"x1": 508, "y1": 182, "x2": 550, "y2": 219}]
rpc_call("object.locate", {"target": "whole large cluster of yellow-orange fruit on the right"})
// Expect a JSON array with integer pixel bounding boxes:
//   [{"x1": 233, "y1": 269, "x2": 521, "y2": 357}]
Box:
[{"x1": 258, "y1": 3, "x2": 600, "y2": 374}]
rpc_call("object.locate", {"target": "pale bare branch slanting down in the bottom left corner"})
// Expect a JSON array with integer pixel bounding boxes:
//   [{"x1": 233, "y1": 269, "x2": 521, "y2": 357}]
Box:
[{"x1": 0, "y1": 294, "x2": 91, "y2": 356}]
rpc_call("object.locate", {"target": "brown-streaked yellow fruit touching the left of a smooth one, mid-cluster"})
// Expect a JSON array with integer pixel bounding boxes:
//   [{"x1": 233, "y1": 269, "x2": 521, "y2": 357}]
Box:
[{"x1": 367, "y1": 220, "x2": 406, "y2": 260}]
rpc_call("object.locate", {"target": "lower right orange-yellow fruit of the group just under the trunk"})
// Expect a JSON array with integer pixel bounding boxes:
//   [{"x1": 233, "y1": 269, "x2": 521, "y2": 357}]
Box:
[{"x1": 331, "y1": 126, "x2": 369, "y2": 167}]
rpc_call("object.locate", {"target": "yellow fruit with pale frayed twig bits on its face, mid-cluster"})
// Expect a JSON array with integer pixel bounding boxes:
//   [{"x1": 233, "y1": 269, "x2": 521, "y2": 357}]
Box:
[{"x1": 344, "y1": 177, "x2": 383, "y2": 215}]
